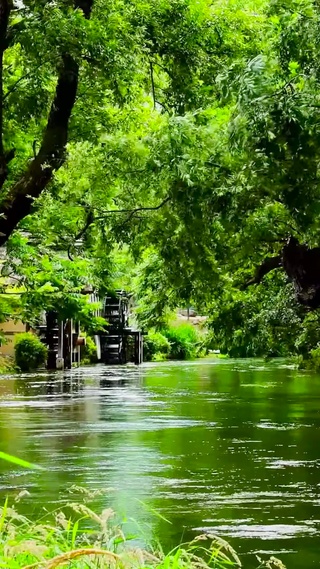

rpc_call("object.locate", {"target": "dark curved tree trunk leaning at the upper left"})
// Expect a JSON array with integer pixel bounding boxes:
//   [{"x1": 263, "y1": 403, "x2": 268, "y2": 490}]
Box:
[{"x1": 0, "y1": 0, "x2": 93, "y2": 245}]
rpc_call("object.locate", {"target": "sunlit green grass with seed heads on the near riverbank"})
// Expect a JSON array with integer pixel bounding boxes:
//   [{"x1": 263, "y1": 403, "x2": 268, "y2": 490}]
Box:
[{"x1": 0, "y1": 493, "x2": 285, "y2": 569}]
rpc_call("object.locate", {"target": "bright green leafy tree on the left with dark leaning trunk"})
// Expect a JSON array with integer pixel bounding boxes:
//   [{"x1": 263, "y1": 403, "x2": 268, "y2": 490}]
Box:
[{"x1": 0, "y1": 0, "x2": 263, "y2": 316}]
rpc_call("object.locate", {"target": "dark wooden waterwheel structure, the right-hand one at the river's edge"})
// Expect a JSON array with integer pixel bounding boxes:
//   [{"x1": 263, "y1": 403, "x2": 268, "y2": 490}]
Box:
[{"x1": 99, "y1": 290, "x2": 143, "y2": 365}]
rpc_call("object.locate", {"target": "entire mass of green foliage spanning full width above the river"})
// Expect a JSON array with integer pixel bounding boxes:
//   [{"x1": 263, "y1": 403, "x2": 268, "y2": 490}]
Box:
[{"x1": 0, "y1": 0, "x2": 320, "y2": 356}]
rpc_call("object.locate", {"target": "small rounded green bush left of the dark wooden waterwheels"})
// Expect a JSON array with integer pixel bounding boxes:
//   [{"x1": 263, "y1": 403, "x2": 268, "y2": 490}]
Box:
[{"x1": 14, "y1": 332, "x2": 48, "y2": 371}]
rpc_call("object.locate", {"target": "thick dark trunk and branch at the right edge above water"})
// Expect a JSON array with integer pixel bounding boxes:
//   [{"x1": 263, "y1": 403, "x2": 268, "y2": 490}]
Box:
[{"x1": 244, "y1": 237, "x2": 320, "y2": 310}]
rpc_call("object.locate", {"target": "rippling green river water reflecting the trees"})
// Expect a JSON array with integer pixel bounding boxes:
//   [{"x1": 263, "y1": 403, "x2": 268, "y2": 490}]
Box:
[{"x1": 0, "y1": 360, "x2": 320, "y2": 569}]
